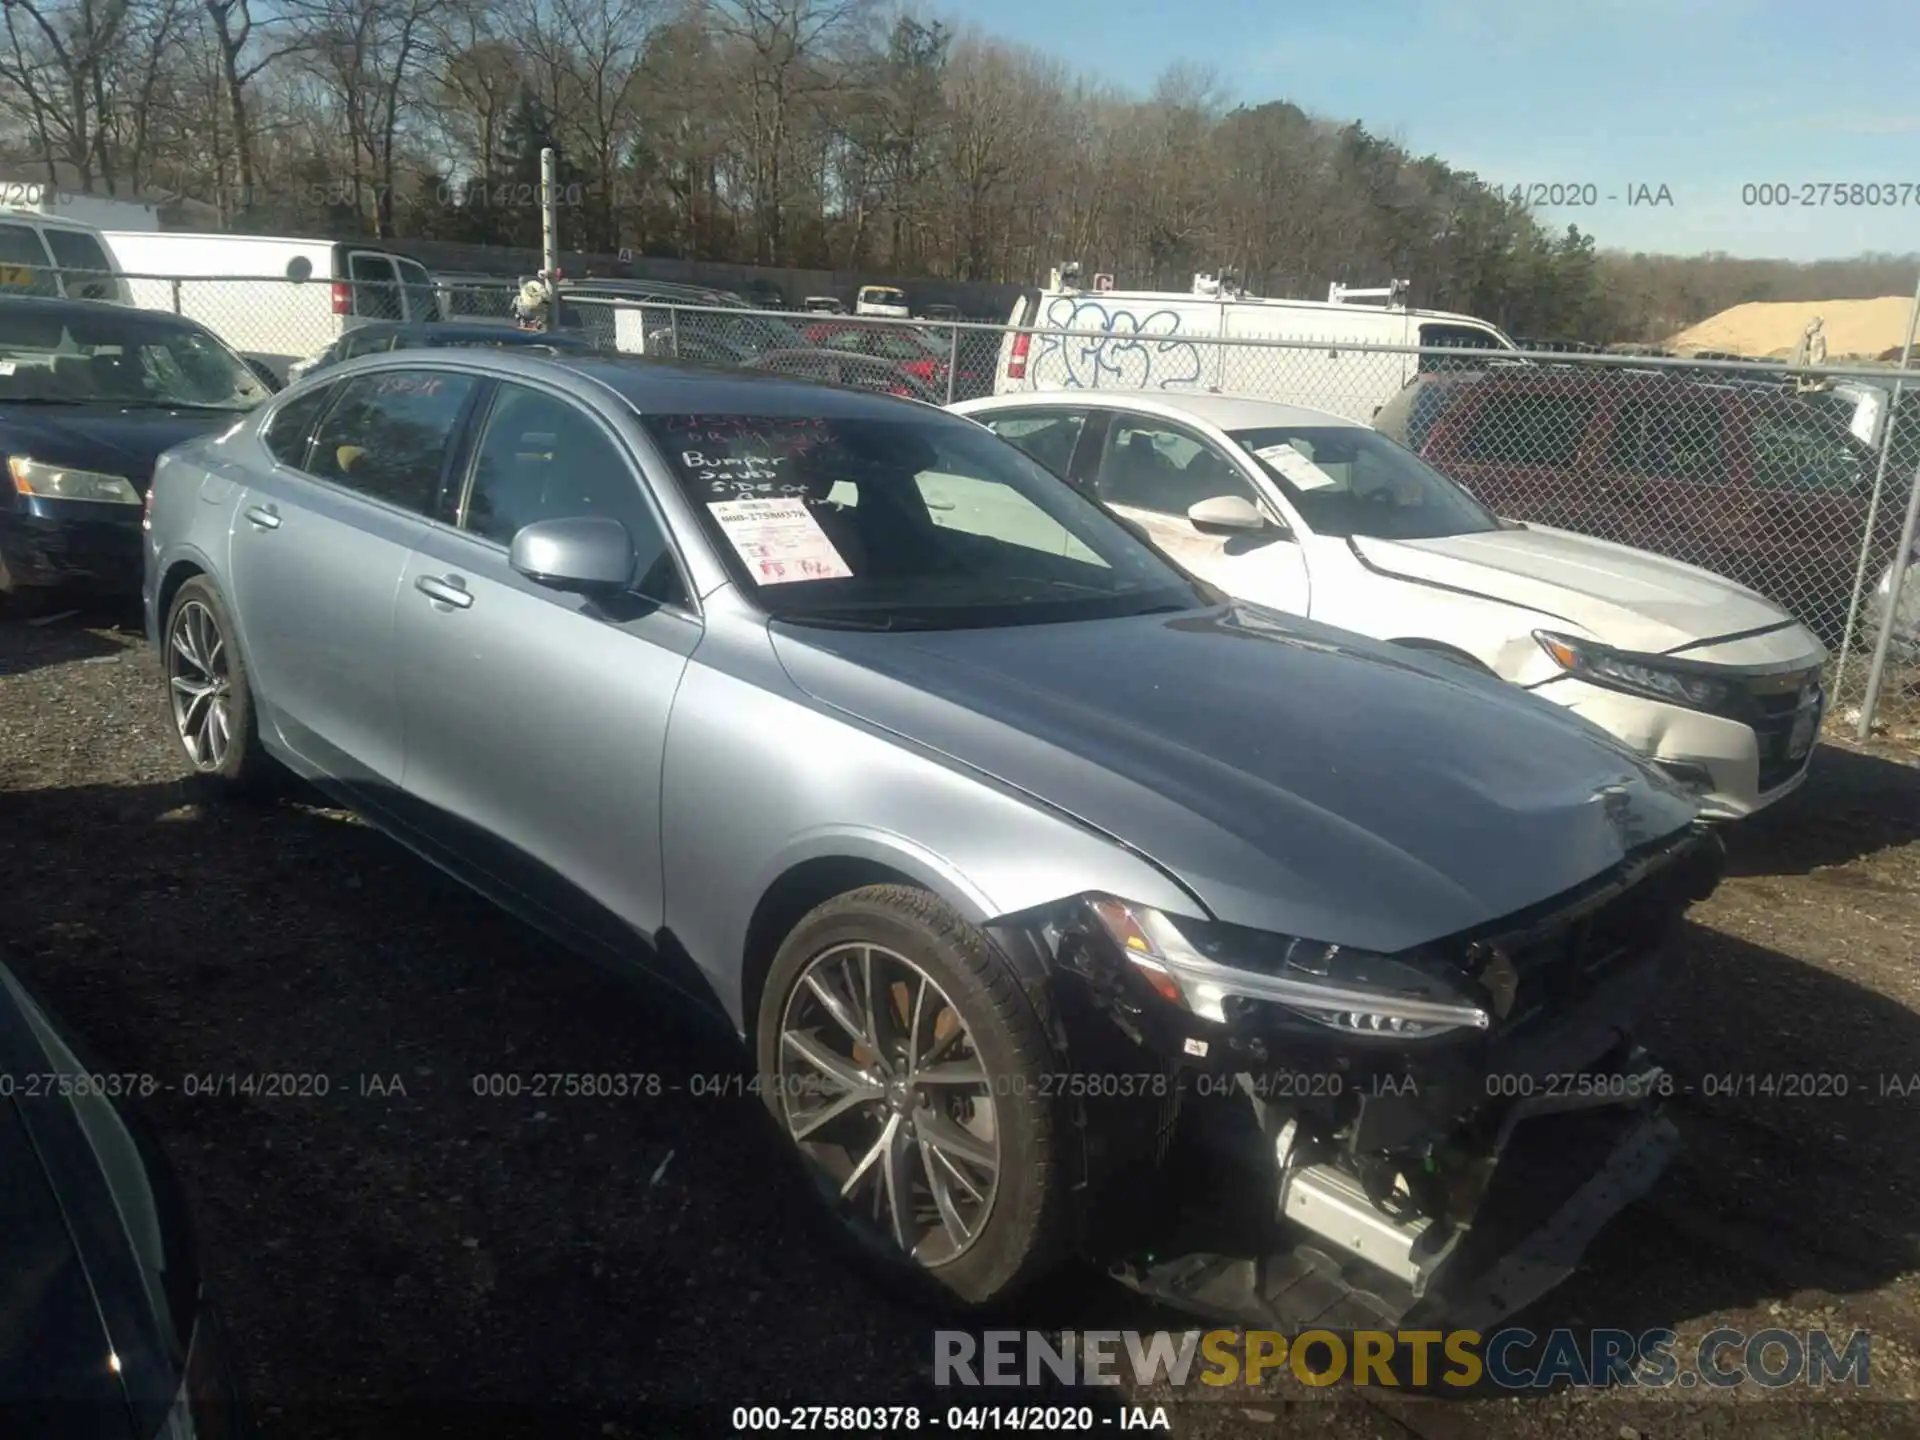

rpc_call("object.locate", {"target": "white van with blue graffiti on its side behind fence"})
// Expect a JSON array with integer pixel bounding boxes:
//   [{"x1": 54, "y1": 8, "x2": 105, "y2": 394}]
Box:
[{"x1": 993, "y1": 271, "x2": 1515, "y2": 422}]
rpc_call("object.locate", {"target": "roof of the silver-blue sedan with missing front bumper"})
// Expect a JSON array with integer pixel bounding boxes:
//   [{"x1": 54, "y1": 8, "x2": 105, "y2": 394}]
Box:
[{"x1": 318, "y1": 351, "x2": 975, "y2": 424}]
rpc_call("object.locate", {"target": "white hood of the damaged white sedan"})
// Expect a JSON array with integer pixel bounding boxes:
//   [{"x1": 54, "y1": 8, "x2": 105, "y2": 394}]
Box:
[{"x1": 1352, "y1": 524, "x2": 1793, "y2": 655}]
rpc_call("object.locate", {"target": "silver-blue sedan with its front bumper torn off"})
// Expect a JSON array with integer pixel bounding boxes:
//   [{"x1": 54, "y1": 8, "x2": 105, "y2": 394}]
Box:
[{"x1": 146, "y1": 351, "x2": 1720, "y2": 1317}]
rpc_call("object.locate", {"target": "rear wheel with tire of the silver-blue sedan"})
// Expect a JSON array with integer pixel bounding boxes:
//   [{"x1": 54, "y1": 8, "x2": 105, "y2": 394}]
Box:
[{"x1": 159, "y1": 576, "x2": 273, "y2": 791}]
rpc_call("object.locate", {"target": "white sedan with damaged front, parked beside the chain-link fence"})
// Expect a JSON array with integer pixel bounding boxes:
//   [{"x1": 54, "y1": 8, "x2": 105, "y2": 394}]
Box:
[{"x1": 952, "y1": 390, "x2": 1826, "y2": 820}]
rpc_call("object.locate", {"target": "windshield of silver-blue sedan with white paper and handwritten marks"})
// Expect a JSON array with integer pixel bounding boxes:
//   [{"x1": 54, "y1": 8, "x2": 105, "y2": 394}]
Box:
[{"x1": 645, "y1": 407, "x2": 1210, "y2": 630}]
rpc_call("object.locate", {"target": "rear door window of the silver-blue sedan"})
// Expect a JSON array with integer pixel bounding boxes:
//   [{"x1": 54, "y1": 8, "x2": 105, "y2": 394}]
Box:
[{"x1": 307, "y1": 371, "x2": 480, "y2": 515}]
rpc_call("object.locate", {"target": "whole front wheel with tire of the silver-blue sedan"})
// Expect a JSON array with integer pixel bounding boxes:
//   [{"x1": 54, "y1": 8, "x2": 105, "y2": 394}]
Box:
[{"x1": 756, "y1": 885, "x2": 1066, "y2": 1308}]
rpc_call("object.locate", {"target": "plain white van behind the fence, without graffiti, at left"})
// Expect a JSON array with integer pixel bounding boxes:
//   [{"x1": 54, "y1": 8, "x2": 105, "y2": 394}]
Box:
[{"x1": 106, "y1": 230, "x2": 440, "y2": 378}]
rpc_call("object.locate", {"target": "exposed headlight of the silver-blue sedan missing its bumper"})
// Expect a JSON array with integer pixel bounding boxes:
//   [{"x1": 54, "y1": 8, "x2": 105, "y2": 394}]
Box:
[{"x1": 1087, "y1": 897, "x2": 1492, "y2": 1039}]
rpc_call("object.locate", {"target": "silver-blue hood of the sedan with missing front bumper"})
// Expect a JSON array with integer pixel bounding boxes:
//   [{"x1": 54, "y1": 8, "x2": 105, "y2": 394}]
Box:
[{"x1": 774, "y1": 603, "x2": 1695, "y2": 952}]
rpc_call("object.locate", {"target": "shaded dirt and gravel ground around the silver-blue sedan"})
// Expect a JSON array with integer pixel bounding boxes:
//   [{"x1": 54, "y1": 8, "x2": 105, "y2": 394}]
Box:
[{"x1": 0, "y1": 612, "x2": 1920, "y2": 1440}]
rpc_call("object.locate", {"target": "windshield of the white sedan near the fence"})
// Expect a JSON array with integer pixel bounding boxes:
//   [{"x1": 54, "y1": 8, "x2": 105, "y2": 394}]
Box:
[{"x1": 1233, "y1": 426, "x2": 1500, "y2": 540}]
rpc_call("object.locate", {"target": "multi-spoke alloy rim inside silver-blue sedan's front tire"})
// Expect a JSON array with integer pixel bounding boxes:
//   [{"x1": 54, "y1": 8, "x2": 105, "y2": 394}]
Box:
[{"x1": 778, "y1": 945, "x2": 1000, "y2": 1267}]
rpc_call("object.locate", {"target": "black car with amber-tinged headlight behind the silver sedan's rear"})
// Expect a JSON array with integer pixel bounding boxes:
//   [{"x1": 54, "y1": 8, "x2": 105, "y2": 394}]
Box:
[{"x1": 0, "y1": 298, "x2": 273, "y2": 609}]
